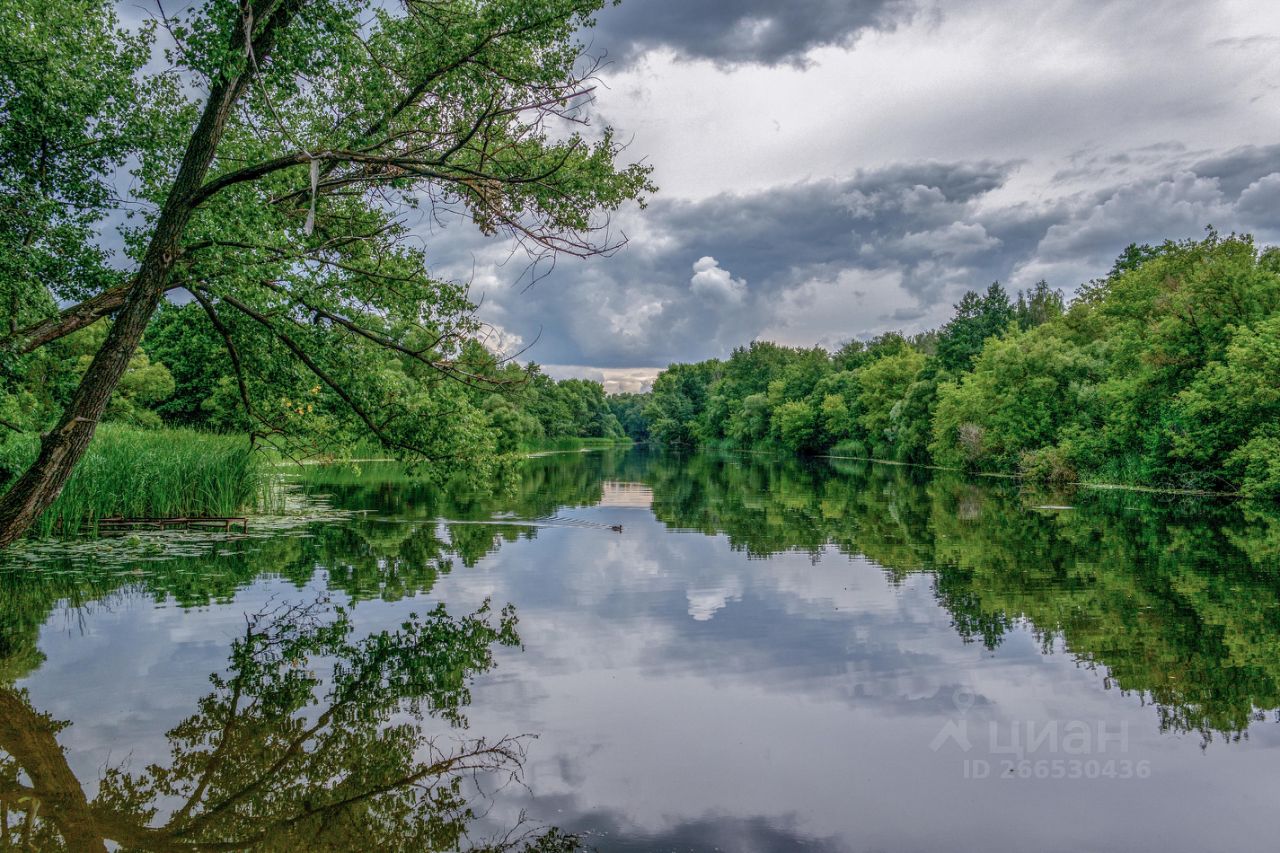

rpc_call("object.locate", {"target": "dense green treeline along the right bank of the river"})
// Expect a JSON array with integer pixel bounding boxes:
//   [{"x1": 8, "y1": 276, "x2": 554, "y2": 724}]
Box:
[{"x1": 611, "y1": 231, "x2": 1280, "y2": 498}]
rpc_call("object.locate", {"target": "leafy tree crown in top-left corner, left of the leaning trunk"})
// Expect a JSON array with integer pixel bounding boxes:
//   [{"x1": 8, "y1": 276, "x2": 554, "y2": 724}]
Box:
[{"x1": 0, "y1": 0, "x2": 149, "y2": 342}]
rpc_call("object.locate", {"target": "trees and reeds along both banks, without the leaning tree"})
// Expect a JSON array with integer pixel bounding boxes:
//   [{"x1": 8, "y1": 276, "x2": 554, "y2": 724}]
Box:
[{"x1": 0, "y1": 232, "x2": 1280, "y2": 545}]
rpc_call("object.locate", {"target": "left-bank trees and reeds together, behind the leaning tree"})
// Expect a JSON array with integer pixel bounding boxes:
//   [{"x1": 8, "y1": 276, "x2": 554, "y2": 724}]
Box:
[{"x1": 0, "y1": 301, "x2": 628, "y2": 535}]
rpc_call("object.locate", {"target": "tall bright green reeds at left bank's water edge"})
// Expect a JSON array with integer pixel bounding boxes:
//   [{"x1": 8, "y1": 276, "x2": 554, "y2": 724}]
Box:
[{"x1": 0, "y1": 424, "x2": 269, "y2": 537}]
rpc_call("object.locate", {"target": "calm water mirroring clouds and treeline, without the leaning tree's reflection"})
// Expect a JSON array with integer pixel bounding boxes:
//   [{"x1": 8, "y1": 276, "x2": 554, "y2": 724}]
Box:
[{"x1": 0, "y1": 451, "x2": 1280, "y2": 850}]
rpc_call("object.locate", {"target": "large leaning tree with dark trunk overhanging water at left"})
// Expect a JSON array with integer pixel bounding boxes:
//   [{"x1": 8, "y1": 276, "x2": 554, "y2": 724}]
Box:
[{"x1": 0, "y1": 0, "x2": 652, "y2": 544}]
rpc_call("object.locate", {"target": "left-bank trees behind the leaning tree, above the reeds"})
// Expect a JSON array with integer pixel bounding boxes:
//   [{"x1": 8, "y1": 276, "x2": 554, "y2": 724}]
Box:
[{"x1": 0, "y1": 302, "x2": 626, "y2": 458}]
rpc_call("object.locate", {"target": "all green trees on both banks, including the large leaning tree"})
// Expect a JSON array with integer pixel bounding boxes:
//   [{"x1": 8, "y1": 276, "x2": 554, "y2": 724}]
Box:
[{"x1": 0, "y1": 0, "x2": 1280, "y2": 544}]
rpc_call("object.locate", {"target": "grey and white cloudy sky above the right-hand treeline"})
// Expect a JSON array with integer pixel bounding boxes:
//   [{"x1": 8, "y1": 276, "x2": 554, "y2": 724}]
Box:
[{"x1": 419, "y1": 0, "x2": 1280, "y2": 389}]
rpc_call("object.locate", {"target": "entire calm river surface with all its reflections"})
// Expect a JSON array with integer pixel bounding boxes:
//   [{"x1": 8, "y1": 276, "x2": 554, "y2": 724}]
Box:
[{"x1": 0, "y1": 448, "x2": 1280, "y2": 852}]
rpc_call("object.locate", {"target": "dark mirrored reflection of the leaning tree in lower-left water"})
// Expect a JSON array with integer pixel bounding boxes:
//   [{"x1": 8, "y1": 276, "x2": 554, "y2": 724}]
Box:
[{"x1": 0, "y1": 602, "x2": 579, "y2": 853}]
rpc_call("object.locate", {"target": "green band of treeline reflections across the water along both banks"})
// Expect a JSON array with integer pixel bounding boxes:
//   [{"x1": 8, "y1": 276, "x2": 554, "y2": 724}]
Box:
[{"x1": 0, "y1": 451, "x2": 1280, "y2": 735}]
